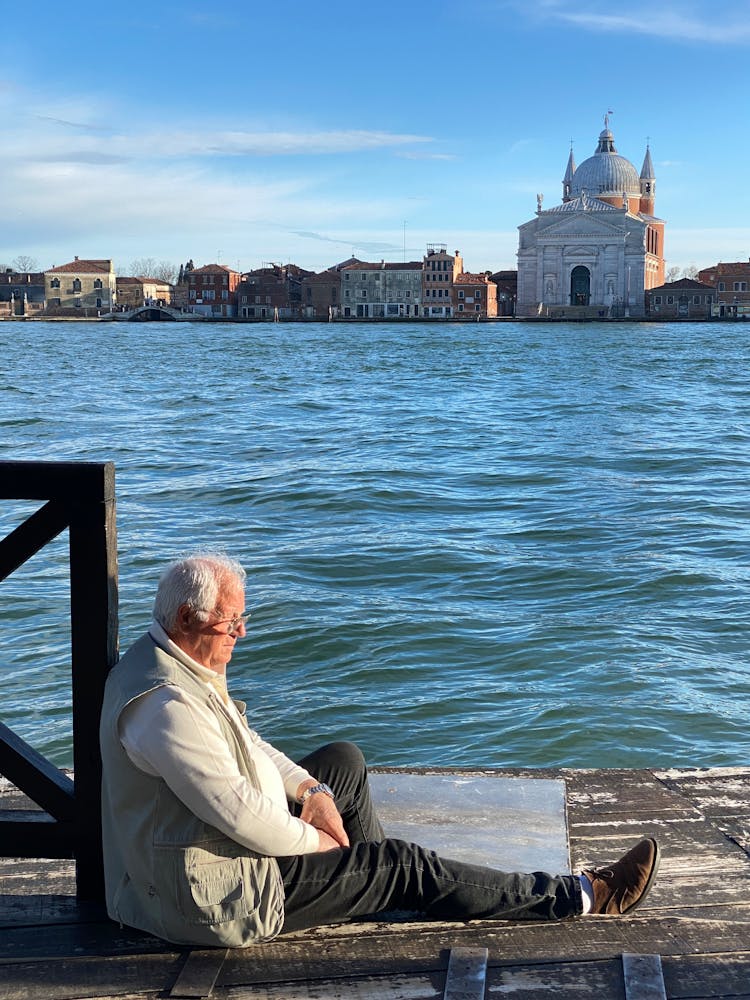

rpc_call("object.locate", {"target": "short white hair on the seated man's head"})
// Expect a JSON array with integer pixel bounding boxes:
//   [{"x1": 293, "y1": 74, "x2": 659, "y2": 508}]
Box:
[{"x1": 154, "y1": 552, "x2": 247, "y2": 632}]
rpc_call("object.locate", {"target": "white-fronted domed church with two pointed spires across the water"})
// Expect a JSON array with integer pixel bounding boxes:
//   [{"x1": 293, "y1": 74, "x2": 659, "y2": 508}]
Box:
[{"x1": 516, "y1": 115, "x2": 664, "y2": 319}]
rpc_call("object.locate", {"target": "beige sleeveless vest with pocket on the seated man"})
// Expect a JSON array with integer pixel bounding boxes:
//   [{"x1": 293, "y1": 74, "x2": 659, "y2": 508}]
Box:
[{"x1": 100, "y1": 635, "x2": 284, "y2": 948}]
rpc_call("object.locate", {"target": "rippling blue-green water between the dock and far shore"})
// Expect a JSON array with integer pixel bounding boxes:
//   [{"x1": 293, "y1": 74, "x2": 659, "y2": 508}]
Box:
[{"x1": 0, "y1": 322, "x2": 750, "y2": 767}]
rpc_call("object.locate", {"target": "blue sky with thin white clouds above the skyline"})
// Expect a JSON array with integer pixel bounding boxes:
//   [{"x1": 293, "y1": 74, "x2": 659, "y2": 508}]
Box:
[{"x1": 0, "y1": 0, "x2": 750, "y2": 273}]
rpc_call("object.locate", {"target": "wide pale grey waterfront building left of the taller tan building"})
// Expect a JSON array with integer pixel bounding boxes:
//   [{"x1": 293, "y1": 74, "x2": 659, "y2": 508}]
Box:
[{"x1": 341, "y1": 260, "x2": 423, "y2": 319}]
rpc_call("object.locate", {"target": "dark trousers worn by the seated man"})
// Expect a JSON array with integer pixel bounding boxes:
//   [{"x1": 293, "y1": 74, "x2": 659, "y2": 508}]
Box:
[{"x1": 278, "y1": 743, "x2": 582, "y2": 931}]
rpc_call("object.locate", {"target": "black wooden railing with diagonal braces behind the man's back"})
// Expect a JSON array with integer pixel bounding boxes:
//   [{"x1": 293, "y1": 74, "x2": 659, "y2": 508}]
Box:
[{"x1": 0, "y1": 462, "x2": 117, "y2": 899}]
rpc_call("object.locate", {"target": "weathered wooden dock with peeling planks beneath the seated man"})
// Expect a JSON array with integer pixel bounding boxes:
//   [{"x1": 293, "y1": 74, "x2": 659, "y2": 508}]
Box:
[{"x1": 0, "y1": 767, "x2": 750, "y2": 1000}]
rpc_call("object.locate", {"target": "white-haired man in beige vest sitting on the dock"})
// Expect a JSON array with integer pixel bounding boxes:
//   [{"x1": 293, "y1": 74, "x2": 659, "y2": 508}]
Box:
[{"x1": 100, "y1": 554, "x2": 659, "y2": 947}]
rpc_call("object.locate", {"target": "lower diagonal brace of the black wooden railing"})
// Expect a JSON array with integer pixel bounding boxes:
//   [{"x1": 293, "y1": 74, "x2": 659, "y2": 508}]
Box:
[{"x1": 0, "y1": 722, "x2": 75, "y2": 821}]
